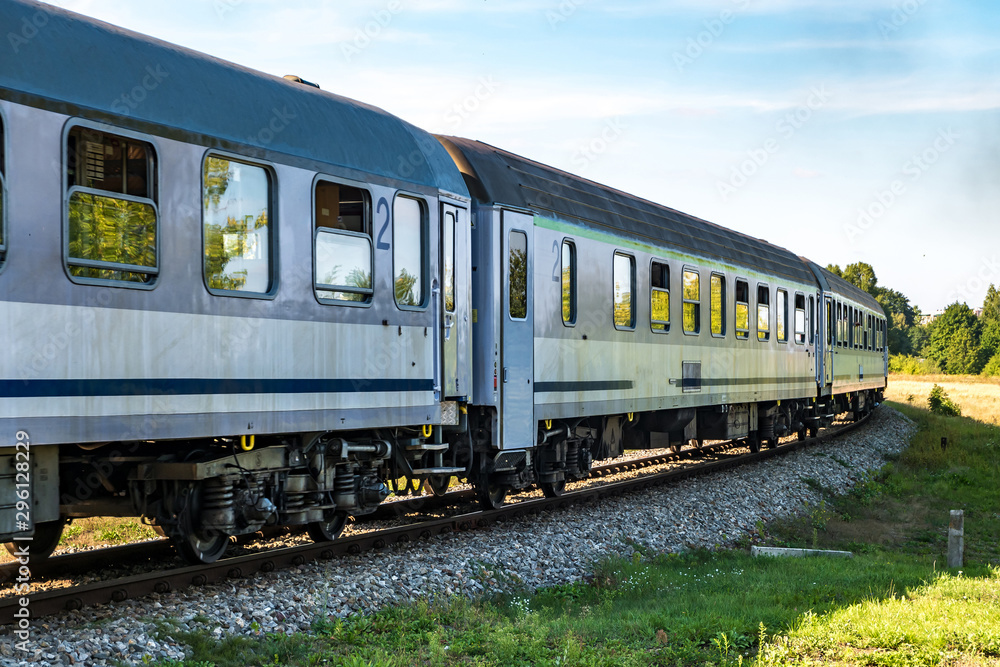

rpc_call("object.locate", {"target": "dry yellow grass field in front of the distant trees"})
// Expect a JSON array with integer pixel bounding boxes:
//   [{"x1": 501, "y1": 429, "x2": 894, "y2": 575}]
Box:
[{"x1": 885, "y1": 375, "x2": 1000, "y2": 425}]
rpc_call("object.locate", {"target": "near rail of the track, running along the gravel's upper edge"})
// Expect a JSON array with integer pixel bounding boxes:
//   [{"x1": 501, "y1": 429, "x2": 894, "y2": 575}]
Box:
[{"x1": 0, "y1": 416, "x2": 868, "y2": 625}]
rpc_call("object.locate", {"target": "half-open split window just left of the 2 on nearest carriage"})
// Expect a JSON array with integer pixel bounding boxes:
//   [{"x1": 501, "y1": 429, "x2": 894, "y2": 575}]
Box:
[{"x1": 313, "y1": 181, "x2": 373, "y2": 304}]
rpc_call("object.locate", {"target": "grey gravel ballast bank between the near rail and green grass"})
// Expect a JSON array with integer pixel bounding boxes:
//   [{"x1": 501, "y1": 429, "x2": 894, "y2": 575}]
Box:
[{"x1": 0, "y1": 406, "x2": 915, "y2": 666}]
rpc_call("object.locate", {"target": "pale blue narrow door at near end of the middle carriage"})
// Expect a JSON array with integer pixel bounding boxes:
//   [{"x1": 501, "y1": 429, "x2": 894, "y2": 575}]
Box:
[{"x1": 500, "y1": 211, "x2": 535, "y2": 449}]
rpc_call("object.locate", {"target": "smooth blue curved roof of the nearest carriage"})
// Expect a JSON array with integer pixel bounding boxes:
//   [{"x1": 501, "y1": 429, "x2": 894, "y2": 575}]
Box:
[{"x1": 0, "y1": 0, "x2": 467, "y2": 195}]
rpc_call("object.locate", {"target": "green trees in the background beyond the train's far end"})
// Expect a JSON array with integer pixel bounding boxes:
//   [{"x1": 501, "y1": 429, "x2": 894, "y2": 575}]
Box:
[{"x1": 826, "y1": 262, "x2": 1000, "y2": 376}]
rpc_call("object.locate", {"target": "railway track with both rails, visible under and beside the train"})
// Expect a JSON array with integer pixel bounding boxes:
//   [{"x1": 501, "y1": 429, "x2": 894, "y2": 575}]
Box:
[{"x1": 0, "y1": 417, "x2": 867, "y2": 625}]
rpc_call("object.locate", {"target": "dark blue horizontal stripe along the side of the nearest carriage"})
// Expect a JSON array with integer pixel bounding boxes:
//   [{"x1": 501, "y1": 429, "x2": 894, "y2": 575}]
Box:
[{"x1": 0, "y1": 378, "x2": 434, "y2": 398}]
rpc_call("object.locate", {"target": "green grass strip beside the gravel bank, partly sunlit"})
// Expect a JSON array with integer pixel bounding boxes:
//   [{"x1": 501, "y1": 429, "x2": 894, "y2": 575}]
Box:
[{"x1": 148, "y1": 406, "x2": 1000, "y2": 667}]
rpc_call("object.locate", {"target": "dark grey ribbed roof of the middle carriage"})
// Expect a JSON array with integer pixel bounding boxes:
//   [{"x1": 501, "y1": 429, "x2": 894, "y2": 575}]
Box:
[{"x1": 438, "y1": 137, "x2": 828, "y2": 283}]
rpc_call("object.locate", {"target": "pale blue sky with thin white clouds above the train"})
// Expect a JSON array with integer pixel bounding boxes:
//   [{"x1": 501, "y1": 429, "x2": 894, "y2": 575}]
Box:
[{"x1": 39, "y1": 0, "x2": 1000, "y2": 312}]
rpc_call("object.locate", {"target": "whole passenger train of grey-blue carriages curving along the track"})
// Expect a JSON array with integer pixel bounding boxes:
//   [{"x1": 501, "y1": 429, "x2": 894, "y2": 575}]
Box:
[{"x1": 0, "y1": 0, "x2": 887, "y2": 562}]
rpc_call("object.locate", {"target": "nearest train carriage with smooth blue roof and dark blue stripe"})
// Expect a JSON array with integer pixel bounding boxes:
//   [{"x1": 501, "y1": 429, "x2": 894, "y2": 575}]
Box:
[{"x1": 0, "y1": 0, "x2": 472, "y2": 560}]
